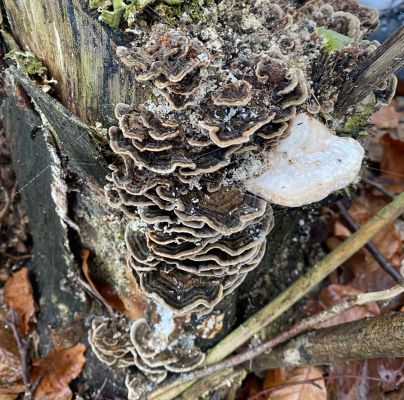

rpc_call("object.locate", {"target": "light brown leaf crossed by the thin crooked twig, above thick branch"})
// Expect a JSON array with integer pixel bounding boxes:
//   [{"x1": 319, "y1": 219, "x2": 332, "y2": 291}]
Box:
[{"x1": 317, "y1": 284, "x2": 380, "y2": 328}]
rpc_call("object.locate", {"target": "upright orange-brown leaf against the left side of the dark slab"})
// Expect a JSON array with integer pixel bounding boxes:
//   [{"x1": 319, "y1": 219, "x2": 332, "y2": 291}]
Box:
[{"x1": 4, "y1": 268, "x2": 35, "y2": 335}]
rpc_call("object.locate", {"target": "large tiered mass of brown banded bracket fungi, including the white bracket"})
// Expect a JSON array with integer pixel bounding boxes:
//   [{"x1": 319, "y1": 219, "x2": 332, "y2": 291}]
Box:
[{"x1": 106, "y1": 0, "x2": 394, "y2": 318}]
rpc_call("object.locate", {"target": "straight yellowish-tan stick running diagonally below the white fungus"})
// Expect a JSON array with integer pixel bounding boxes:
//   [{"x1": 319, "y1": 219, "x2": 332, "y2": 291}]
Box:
[{"x1": 148, "y1": 193, "x2": 404, "y2": 400}]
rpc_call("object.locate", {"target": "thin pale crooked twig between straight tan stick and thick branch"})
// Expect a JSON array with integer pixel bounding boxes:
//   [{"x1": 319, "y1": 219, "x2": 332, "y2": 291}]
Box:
[{"x1": 150, "y1": 285, "x2": 404, "y2": 389}]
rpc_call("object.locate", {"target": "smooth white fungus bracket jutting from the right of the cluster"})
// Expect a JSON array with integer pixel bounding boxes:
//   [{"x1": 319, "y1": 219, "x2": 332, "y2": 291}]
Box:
[{"x1": 246, "y1": 114, "x2": 365, "y2": 207}]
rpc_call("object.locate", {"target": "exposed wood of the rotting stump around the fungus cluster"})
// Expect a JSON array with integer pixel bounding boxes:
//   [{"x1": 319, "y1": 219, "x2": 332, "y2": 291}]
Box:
[{"x1": 1, "y1": 0, "x2": 307, "y2": 399}]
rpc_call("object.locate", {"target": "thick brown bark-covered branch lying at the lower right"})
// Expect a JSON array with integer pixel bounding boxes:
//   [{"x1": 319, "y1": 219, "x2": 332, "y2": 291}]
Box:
[{"x1": 249, "y1": 312, "x2": 404, "y2": 371}]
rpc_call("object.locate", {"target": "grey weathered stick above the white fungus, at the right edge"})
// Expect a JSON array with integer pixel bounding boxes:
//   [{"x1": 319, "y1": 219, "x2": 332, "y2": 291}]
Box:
[{"x1": 335, "y1": 26, "x2": 404, "y2": 115}]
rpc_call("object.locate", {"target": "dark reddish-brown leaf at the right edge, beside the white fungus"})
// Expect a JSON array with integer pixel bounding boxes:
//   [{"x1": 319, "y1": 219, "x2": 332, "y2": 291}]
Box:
[{"x1": 380, "y1": 134, "x2": 404, "y2": 193}]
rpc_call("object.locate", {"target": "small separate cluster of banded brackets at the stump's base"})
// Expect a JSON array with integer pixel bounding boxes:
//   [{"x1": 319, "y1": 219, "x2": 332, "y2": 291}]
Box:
[{"x1": 89, "y1": 318, "x2": 205, "y2": 383}]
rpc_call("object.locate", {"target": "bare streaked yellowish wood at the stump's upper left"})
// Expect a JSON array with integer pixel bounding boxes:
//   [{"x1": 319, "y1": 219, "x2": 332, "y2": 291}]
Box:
[{"x1": 2, "y1": 0, "x2": 152, "y2": 124}]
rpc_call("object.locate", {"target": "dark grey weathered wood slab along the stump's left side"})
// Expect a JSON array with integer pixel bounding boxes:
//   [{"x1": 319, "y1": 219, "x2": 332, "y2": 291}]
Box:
[{"x1": 1, "y1": 71, "x2": 125, "y2": 398}]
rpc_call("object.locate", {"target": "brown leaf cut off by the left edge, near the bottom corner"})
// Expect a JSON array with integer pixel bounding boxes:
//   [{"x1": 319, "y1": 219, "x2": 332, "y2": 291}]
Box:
[{"x1": 0, "y1": 322, "x2": 22, "y2": 386}]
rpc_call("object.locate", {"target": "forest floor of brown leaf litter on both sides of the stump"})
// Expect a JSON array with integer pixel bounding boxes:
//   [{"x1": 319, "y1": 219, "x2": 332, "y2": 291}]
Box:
[{"x1": 0, "y1": 86, "x2": 404, "y2": 400}]
